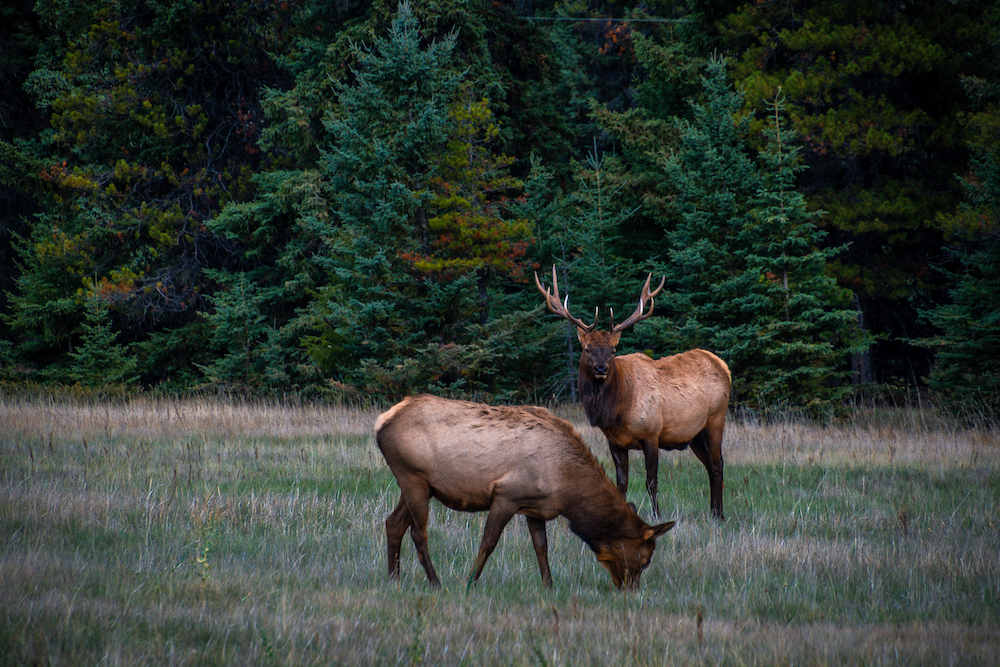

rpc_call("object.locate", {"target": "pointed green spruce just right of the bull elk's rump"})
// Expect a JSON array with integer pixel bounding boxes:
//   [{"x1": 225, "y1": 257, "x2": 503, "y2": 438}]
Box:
[{"x1": 730, "y1": 91, "x2": 869, "y2": 409}]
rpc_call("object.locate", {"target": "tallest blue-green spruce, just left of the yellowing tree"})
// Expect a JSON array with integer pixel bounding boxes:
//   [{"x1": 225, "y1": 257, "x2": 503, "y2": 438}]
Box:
[{"x1": 308, "y1": 3, "x2": 460, "y2": 394}]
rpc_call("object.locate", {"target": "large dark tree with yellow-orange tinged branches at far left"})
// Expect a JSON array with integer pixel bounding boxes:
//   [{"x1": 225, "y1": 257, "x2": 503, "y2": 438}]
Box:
[{"x1": 8, "y1": 2, "x2": 292, "y2": 382}]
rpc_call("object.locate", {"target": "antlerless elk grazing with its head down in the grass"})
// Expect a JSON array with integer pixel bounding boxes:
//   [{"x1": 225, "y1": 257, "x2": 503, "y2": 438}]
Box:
[{"x1": 375, "y1": 394, "x2": 674, "y2": 588}]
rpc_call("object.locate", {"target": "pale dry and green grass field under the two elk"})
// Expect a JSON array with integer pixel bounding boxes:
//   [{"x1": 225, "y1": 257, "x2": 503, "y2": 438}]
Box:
[{"x1": 0, "y1": 397, "x2": 1000, "y2": 665}]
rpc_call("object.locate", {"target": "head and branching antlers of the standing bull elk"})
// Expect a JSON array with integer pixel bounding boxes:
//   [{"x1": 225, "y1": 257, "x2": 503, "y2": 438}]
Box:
[{"x1": 535, "y1": 266, "x2": 666, "y2": 381}]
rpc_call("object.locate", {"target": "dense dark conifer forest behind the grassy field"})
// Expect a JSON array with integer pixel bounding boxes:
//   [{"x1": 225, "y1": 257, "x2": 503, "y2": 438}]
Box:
[{"x1": 0, "y1": 0, "x2": 1000, "y2": 418}]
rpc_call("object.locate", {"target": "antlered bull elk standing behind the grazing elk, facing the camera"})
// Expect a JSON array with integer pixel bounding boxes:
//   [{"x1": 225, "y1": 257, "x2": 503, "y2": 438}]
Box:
[{"x1": 535, "y1": 266, "x2": 732, "y2": 521}]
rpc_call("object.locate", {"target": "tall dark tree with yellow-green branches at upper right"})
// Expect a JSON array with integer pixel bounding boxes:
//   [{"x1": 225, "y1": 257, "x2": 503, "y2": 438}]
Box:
[{"x1": 722, "y1": 0, "x2": 996, "y2": 380}]
